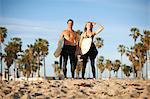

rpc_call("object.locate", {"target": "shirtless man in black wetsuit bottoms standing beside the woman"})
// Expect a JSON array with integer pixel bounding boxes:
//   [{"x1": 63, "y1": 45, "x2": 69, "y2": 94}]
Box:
[{"x1": 60, "y1": 19, "x2": 77, "y2": 78}]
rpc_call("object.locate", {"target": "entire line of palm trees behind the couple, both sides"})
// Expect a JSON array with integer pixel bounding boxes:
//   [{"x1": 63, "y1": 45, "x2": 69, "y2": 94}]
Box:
[{"x1": 0, "y1": 27, "x2": 150, "y2": 79}]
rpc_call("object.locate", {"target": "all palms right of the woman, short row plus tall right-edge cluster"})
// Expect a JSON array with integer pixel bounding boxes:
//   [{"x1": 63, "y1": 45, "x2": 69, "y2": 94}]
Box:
[{"x1": 97, "y1": 28, "x2": 150, "y2": 79}]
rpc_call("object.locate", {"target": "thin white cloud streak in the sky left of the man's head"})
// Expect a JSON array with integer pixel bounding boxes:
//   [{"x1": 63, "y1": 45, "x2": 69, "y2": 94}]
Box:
[{"x1": 0, "y1": 17, "x2": 63, "y2": 33}]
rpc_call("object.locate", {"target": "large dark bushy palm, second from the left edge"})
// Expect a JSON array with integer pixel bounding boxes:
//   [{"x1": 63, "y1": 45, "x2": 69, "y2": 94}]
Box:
[{"x1": 4, "y1": 38, "x2": 22, "y2": 80}]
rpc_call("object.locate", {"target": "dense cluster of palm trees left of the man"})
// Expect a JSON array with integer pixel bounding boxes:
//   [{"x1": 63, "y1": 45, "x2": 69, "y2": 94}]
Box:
[{"x1": 0, "y1": 27, "x2": 49, "y2": 80}]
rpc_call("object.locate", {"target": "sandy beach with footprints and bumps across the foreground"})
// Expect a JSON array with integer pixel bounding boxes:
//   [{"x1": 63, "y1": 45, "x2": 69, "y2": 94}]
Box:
[{"x1": 0, "y1": 79, "x2": 150, "y2": 99}]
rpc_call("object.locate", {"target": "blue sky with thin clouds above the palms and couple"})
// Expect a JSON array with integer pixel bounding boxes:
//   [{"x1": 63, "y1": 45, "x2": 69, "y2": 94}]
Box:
[{"x1": 0, "y1": 0, "x2": 150, "y2": 76}]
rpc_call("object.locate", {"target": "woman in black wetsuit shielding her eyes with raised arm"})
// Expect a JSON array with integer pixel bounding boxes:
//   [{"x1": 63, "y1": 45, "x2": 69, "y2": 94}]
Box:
[{"x1": 79, "y1": 22, "x2": 104, "y2": 79}]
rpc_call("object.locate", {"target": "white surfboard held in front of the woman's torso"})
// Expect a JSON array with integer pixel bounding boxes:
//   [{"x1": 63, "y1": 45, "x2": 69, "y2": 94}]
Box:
[{"x1": 81, "y1": 38, "x2": 92, "y2": 55}]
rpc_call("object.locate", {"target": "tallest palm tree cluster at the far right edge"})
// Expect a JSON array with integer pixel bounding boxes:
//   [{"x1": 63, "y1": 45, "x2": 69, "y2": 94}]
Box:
[{"x1": 118, "y1": 27, "x2": 150, "y2": 79}]
